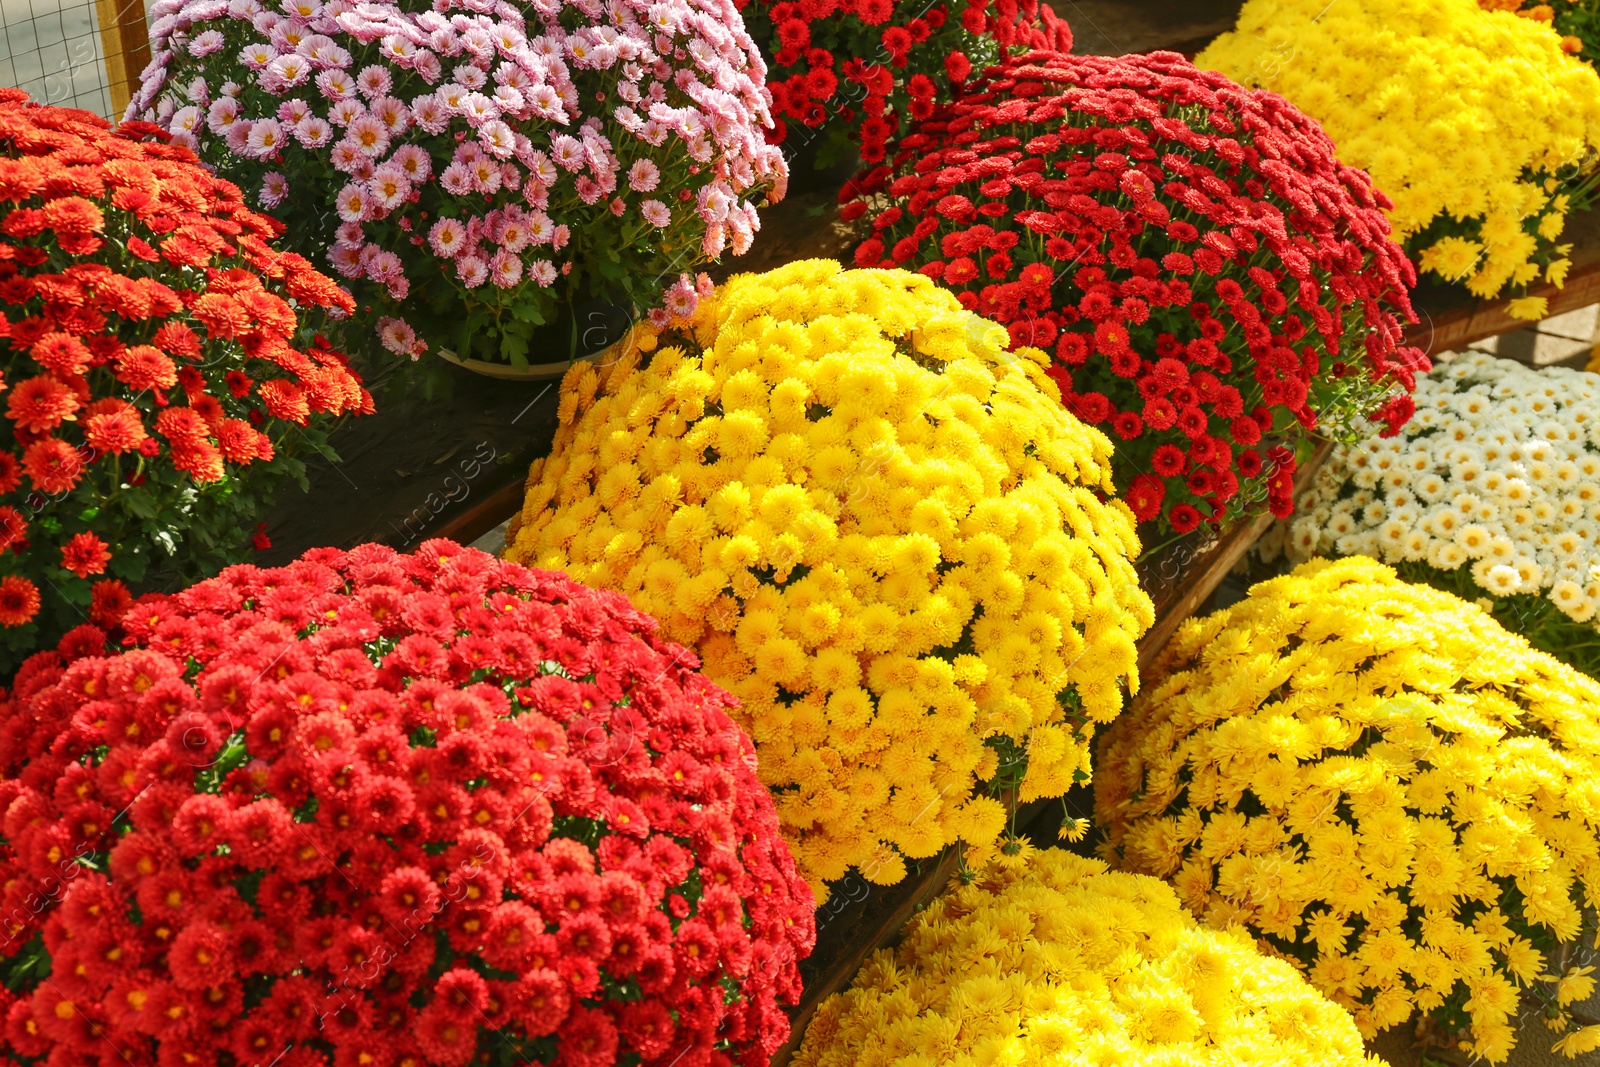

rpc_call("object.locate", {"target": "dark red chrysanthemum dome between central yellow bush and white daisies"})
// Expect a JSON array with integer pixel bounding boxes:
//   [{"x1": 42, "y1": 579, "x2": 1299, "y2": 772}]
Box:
[{"x1": 840, "y1": 53, "x2": 1427, "y2": 534}]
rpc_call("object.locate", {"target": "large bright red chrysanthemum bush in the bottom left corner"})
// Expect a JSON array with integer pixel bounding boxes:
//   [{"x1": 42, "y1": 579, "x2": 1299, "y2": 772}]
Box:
[{"x1": 0, "y1": 541, "x2": 814, "y2": 1067}]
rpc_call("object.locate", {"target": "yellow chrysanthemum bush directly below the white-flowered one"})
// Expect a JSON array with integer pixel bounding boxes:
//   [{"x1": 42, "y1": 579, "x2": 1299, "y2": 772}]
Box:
[{"x1": 1094, "y1": 557, "x2": 1600, "y2": 1062}]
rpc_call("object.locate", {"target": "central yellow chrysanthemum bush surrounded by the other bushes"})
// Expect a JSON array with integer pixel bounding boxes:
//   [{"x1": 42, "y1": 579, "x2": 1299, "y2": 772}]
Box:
[{"x1": 507, "y1": 261, "x2": 1152, "y2": 888}]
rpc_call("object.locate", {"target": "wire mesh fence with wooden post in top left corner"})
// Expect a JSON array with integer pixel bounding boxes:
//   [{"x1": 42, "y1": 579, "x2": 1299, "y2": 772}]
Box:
[{"x1": 0, "y1": 0, "x2": 150, "y2": 120}]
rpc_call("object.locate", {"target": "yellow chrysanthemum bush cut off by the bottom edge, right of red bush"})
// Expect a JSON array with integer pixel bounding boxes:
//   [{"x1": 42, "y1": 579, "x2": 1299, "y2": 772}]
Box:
[{"x1": 794, "y1": 849, "x2": 1373, "y2": 1067}]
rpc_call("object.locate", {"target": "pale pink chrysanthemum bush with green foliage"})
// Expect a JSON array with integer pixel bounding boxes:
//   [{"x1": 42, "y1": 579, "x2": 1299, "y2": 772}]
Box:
[{"x1": 128, "y1": 0, "x2": 787, "y2": 385}]
